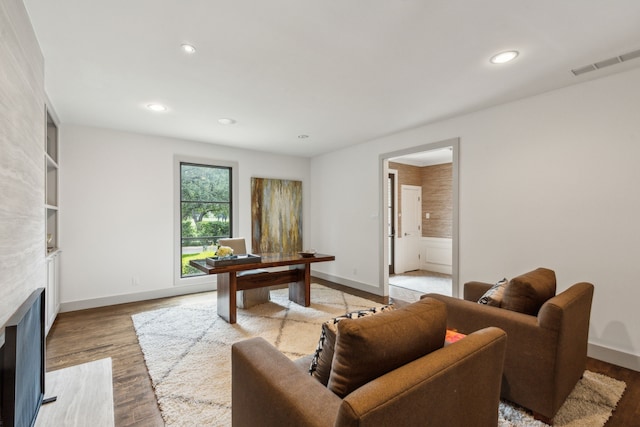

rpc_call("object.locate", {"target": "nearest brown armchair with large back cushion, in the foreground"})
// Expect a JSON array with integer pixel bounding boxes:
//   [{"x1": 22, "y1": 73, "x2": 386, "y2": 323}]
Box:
[{"x1": 232, "y1": 298, "x2": 507, "y2": 427}]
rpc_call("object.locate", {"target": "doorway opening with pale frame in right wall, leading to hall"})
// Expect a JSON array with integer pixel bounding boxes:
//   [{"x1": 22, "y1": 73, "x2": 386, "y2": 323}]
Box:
[{"x1": 379, "y1": 138, "x2": 459, "y2": 296}]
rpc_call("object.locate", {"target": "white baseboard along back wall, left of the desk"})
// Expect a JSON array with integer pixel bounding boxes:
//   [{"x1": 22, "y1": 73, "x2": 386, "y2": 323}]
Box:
[{"x1": 60, "y1": 282, "x2": 216, "y2": 313}]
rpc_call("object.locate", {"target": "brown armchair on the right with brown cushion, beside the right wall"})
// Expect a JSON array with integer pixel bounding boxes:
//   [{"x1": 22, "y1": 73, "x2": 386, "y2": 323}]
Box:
[{"x1": 423, "y1": 268, "x2": 594, "y2": 423}]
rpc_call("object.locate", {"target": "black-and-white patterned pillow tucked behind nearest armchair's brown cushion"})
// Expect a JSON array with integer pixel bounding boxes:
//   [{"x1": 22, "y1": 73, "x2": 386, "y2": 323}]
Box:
[{"x1": 309, "y1": 305, "x2": 394, "y2": 387}]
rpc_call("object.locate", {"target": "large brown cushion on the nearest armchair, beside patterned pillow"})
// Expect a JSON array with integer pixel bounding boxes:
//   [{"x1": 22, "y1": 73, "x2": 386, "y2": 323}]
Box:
[{"x1": 327, "y1": 298, "x2": 447, "y2": 397}]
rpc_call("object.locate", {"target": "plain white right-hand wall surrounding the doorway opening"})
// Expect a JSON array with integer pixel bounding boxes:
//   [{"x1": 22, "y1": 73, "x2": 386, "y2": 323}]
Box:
[{"x1": 311, "y1": 65, "x2": 640, "y2": 369}]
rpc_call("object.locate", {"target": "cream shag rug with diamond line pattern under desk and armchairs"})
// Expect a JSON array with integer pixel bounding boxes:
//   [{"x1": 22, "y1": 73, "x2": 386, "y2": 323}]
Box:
[{"x1": 132, "y1": 284, "x2": 625, "y2": 427}]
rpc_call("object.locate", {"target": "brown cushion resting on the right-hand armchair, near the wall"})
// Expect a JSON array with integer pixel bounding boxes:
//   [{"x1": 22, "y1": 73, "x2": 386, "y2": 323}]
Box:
[{"x1": 501, "y1": 268, "x2": 556, "y2": 316}]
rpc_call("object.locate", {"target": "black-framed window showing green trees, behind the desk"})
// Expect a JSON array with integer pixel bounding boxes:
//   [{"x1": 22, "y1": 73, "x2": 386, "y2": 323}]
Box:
[{"x1": 177, "y1": 161, "x2": 234, "y2": 279}]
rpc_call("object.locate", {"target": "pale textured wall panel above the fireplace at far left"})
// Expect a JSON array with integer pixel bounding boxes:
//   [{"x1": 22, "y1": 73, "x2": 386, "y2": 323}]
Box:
[{"x1": 0, "y1": 0, "x2": 46, "y2": 332}]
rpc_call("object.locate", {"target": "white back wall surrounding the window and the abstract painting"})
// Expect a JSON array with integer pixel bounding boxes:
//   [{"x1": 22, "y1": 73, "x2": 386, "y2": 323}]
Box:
[{"x1": 60, "y1": 125, "x2": 310, "y2": 311}]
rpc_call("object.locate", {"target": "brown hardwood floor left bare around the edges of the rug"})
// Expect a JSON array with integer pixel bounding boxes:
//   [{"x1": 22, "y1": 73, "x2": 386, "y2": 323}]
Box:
[{"x1": 47, "y1": 279, "x2": 640, "y2": 427}]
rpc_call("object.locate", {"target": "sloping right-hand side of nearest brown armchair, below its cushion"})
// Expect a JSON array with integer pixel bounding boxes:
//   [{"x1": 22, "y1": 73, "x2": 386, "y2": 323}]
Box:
[{"x1": 336, "y1": 328, "x2": 507, "y2": 426}]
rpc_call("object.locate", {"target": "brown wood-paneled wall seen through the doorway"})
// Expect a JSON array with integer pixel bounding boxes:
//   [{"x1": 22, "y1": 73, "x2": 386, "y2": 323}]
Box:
[{"x1": 389, "y1": 162, "x2": 453, "y2": 238}]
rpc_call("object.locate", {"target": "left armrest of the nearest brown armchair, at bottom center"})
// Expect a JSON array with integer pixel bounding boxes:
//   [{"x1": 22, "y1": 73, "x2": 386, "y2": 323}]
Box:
[{"x1": 231, "y1": 338, "x2": 342, "y2": 427}]
